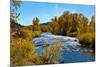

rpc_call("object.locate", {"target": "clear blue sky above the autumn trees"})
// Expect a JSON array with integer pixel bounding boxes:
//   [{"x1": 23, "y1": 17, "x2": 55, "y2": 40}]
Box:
[{"x1": 16, "y1": 1, "x2": 95, "y2": 25}]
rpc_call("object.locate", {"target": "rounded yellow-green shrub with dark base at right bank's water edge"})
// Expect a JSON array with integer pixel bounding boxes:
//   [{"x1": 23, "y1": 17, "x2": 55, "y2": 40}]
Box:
[{"x1": 77, "y1": 32, "x2": 95, "y2": 48}]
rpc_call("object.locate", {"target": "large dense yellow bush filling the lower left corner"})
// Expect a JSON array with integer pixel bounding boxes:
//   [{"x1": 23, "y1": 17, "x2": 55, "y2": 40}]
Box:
[{"x1": 10, "y1": 38, "x2": 36, "y2": 66}]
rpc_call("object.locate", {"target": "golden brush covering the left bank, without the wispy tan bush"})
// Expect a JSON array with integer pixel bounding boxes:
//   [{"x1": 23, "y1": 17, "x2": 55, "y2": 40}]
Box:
[{"x1": 10, "y1": 29, "x2": 40, "y2": 66}]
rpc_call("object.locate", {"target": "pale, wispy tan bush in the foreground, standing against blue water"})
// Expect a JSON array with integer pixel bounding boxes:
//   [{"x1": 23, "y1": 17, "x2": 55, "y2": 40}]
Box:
[{"x1": 35, "y1": 41, "x2": 61, "y2": 64}]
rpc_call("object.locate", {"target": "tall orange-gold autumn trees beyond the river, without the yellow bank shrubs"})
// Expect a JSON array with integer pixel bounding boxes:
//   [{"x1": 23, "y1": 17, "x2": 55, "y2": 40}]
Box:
[{"x1": 33, "y1": 11, "x2": 95, "y2": 36}]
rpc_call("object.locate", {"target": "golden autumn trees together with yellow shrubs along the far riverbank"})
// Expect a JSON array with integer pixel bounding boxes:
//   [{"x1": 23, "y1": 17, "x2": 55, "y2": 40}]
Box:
[{"x1": 31, "y1": 11, "x2": 95, "y2": 49}]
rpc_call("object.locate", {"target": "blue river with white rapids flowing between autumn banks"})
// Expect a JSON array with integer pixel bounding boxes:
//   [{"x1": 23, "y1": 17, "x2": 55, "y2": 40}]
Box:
[{"x1": 33, "y1": 32, "x2": 95, "y2": 63}]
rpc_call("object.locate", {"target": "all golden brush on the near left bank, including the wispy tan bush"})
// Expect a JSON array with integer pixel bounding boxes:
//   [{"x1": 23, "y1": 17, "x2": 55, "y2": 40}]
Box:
[{"x1": 10, "y1": 30, "x2": 61, "y2": 66}]
